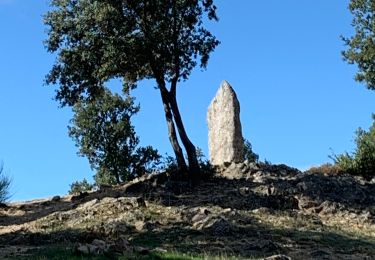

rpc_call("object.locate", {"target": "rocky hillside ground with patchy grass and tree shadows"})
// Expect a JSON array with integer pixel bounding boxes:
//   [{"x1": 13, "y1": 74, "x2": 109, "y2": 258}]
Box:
[{"x1": 0, "y1": 163, "x2": 375, "y2": 259}]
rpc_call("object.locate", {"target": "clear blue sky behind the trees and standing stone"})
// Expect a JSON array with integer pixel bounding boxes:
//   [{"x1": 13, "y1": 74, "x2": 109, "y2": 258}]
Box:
[{"x1": 0, "y1": 0, "x2": 375, "y2": 200}]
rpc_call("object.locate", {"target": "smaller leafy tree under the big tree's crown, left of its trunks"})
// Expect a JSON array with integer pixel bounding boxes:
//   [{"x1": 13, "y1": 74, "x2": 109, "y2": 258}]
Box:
[{"x1": 69, "y1": 90, "x2": 160, "y2": 184}]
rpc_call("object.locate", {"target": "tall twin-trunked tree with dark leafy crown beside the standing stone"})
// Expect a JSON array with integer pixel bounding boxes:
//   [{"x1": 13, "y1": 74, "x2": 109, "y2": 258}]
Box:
[{"x1": 45, "y1": 0, "x2": 219, "y2": 179}]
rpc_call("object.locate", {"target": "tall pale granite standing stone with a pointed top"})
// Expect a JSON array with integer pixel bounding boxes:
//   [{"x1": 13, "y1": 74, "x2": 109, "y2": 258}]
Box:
[{"x1": 207, "y1": 81, "x2": 244, "y2": 165}]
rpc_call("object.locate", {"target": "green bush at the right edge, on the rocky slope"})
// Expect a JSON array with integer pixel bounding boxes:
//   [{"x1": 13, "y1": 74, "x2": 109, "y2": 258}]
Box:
[{"x1": 332, "y1": 116, "x2": 375, "y2": 179}]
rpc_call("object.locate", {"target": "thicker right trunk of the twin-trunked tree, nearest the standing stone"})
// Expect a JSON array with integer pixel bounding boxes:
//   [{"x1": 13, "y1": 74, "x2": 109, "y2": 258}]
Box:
[{"x1": 169, "y1": 92, "x2": 200, "y2": 183}]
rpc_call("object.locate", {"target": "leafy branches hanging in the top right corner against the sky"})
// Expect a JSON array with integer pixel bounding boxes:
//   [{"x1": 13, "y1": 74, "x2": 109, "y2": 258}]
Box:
[{"x1": 343, "y1": 0, "x2": 375, "y2": 90}]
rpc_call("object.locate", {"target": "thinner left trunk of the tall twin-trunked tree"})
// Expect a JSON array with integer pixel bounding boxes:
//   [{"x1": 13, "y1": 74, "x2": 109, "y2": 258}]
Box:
[{"x1": 159, "y1": 87, "x2": 187, "y2": 173}]
